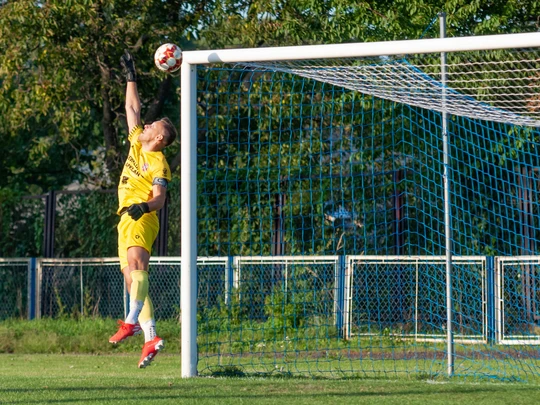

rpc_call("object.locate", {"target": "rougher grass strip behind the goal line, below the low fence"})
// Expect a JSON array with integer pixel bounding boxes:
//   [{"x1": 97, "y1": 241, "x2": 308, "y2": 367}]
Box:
[{"x1": 4, "y1": 318, "x2": 540, "y2": 384}]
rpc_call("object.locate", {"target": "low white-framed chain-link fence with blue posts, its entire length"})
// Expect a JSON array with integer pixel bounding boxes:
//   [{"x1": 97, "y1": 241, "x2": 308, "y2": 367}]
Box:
[{"x1": 0, "y1": 256, "x2": 540, "y2": 344}]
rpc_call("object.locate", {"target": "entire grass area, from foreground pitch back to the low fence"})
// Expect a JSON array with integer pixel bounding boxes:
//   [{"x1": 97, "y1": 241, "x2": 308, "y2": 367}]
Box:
[{"x1": 0, "y1": 319, "x2": 540, "y2": 405}]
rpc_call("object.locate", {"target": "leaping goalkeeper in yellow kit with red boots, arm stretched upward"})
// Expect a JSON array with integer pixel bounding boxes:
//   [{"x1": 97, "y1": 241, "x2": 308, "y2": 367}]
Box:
[{"x1": 109, "y1": 51, "x2": 176, "y2": 368}]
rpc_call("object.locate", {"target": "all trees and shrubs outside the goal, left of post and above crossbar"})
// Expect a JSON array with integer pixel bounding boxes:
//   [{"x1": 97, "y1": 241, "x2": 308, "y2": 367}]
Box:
[{"x1": 0, "y1": 0, "x2": 540, "y2": 257}]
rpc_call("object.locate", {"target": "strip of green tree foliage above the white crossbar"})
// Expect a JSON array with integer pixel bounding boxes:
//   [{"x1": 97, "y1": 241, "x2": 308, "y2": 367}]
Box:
[{"x1": 206, "y1": 0, "x2": 540, "y2": 47}]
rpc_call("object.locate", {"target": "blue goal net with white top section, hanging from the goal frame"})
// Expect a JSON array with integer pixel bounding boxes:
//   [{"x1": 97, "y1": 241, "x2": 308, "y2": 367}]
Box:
[{"x1": 182, "y1": 34, "x2": 540, "y2": 379}]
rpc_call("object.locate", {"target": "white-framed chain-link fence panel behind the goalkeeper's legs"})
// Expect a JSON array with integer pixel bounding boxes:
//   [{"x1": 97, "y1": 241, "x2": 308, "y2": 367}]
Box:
[{"x1": 36, "y1": 257, "x2": 232, "y2": 320}]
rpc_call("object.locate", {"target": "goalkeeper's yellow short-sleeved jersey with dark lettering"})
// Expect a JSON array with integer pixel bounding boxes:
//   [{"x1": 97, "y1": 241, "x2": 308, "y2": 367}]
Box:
[{"x1": 118, "y1": 125, "x2": 171, "y2": 214}]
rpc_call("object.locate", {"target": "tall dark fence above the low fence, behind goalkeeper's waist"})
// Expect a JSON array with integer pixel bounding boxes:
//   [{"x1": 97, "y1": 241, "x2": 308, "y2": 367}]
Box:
[{"x1": 0, "y1": 189, "x2": 170, "y2": 257}]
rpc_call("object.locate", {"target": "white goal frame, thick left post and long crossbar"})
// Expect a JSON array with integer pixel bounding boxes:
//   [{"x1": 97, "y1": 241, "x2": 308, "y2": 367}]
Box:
[{"x1": 180, "y1": 33, "x2": 540, "y2": 377}]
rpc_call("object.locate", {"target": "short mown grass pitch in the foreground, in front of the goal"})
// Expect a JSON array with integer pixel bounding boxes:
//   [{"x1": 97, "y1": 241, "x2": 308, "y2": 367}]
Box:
[{"x1": 0, "y1": 352, "x2": 540, "y2": 405}]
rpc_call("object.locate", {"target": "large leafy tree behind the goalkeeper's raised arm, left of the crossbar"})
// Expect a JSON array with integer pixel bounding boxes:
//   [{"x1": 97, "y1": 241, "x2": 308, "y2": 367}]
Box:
[{"x1": 0, "y1": 0, "x2": 211, "y2": 192}]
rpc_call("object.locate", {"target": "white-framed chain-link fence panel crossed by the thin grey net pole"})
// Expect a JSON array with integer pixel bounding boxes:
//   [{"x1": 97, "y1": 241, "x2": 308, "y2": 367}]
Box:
[{"x1": 348, "y1": 256, "x2": 488, "y2": 341}]
